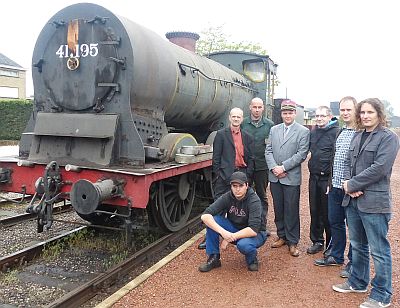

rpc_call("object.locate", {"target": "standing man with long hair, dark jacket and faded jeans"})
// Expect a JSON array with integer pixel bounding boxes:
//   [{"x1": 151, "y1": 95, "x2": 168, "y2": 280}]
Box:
[{"x1": 333, "y1": 98, "x2": 399, "y2": 308}]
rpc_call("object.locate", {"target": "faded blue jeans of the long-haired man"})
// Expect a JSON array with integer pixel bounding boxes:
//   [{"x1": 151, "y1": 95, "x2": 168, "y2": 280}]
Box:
[{"x1": 346, "y1": 199, "x2": 393, "y2": 303}]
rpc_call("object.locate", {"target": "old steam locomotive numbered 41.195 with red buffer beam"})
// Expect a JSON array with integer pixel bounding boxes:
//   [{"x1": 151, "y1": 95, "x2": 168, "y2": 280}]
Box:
[{"x1": 0, "y1": 3, "x2": 277, "y2": 238}]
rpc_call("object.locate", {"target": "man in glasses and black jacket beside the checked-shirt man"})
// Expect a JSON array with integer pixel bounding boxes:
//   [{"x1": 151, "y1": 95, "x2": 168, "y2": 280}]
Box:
[{"x1": 307, "y1": 106, "x2": 339, "y2": 254}]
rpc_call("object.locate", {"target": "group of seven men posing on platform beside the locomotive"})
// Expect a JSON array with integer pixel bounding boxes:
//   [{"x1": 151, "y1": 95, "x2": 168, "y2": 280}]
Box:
[{"x1": 199, "y1": 96, "x2": 399, "y2": 308}]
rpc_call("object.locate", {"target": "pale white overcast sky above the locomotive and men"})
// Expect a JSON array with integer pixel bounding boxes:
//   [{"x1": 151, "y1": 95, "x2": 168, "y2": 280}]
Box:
[{"x1": 0, "y1": 0, "x2": 400, "y2": 115}]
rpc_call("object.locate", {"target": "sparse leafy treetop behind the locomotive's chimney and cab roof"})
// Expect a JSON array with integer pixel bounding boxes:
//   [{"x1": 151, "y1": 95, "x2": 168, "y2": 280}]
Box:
[{"x1": 196, "y1": 25, "x2": 267, "y2": 55}]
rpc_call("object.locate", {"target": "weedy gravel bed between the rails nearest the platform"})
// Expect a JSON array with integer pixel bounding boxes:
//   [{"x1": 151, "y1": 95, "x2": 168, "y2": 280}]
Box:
[{"x1": 0, "y1": 226, "x2": 139, "y2": 307}]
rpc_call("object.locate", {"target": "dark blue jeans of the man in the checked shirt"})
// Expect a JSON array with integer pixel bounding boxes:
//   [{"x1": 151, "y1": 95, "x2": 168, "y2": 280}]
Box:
[{"x1": 328, "y1": 187, "x2": 352, "y2": 263}]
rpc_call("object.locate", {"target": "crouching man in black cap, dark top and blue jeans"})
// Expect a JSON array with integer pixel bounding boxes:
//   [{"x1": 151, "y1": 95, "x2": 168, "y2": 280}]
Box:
[{"x1": 199, "y1": 171, "x2": 267, "y2": 272}]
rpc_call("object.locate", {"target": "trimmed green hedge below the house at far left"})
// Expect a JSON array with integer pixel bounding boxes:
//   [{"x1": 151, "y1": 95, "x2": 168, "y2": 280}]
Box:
[{"x1": 0, "y1": 99, "x2": 32, "y2": 140}]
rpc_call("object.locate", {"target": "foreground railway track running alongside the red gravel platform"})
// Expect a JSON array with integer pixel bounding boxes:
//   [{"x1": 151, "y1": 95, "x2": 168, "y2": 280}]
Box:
[{"x1": 0, "y1": 205, "x2": 201, "y2": 307}]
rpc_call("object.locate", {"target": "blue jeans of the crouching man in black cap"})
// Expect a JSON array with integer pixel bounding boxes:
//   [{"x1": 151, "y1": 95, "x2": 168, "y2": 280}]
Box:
[{"x1": 206, "y1": 215, "x2": 267, "y2": 265}]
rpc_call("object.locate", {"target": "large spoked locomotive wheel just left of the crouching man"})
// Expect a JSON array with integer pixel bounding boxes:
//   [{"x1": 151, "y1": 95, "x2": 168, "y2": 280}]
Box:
[{"x1": 150, "y1": 173, "x2": 196, "y2": 232}]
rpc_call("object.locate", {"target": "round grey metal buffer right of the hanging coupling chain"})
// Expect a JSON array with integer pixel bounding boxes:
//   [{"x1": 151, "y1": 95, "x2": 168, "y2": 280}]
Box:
[{"x1": 70, "y1": 180, "x2": 117, "y2": 215}]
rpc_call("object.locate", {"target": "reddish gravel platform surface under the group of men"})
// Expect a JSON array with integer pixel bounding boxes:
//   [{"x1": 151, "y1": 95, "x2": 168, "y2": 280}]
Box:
[{"x1": 113, "y1": 155, "x2": 400, "y2": 308}]
